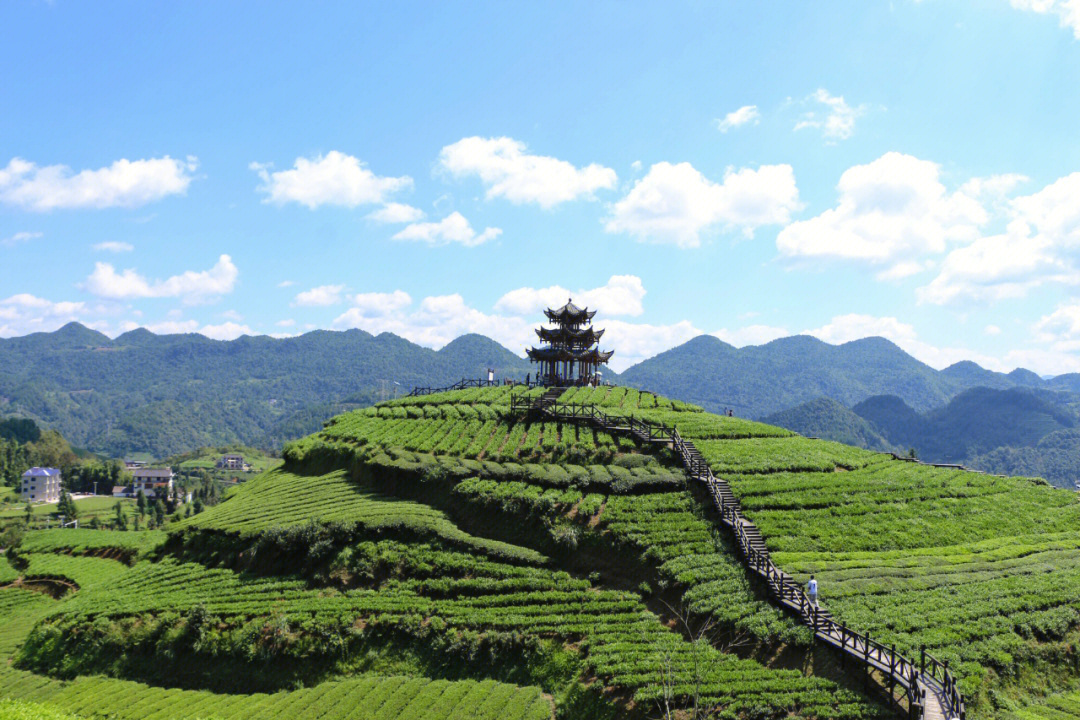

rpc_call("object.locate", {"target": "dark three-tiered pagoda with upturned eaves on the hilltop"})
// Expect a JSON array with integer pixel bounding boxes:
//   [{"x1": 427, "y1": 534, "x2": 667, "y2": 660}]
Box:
[{"x1": 528, "y1": 300, "x2": 615, "y2": 385}]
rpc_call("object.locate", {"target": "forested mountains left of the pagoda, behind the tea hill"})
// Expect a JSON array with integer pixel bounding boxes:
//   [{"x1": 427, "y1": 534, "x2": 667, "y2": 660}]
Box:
[{"x1": 0, "y1": 323, "x2": 529, "y2": 458}]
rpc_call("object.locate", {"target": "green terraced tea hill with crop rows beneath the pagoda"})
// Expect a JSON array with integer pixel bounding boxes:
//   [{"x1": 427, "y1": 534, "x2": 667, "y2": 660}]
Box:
[{"x1": 0, "y1": 388, "x2": 1080, "y2": 720}]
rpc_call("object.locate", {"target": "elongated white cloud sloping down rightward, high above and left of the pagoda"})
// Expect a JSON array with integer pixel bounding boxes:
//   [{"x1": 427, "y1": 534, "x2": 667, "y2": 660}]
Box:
[{"x1": 438, "y1": 137, "x2": 617, "y2": 208}]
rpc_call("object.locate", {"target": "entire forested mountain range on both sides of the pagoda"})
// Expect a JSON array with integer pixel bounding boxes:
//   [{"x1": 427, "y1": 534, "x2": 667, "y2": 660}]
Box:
[{"x1": 0, "y1": 323, "x2": 1080, "y2": 474}]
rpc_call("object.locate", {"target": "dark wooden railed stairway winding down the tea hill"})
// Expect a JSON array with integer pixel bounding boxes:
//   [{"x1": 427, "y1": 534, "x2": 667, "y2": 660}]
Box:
[{"x1": 511, "y1": 395, "x2": 966, "y2": 720}]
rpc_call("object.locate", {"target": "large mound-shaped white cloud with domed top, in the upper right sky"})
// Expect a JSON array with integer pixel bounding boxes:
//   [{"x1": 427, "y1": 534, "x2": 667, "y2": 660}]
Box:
[{"x1": 777, "y1": 152, "x2": 988, "y2": 266}]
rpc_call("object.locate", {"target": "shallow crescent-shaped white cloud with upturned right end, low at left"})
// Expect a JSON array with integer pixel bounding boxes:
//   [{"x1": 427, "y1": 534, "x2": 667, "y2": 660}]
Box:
[{"x1": 83, "y1": 255, "x2": 240, "y2": 303}]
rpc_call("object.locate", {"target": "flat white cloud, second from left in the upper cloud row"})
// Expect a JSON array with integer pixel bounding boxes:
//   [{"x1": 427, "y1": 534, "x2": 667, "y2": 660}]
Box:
[{"x1": 249, "y1": 150, "x2": 413, "y2": 209}]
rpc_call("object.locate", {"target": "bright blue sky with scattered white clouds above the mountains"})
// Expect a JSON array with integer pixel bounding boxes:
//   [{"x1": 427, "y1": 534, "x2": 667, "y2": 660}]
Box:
[{"x1": 6, "y1": 0, "x2": 1080, "y2": 375}]
